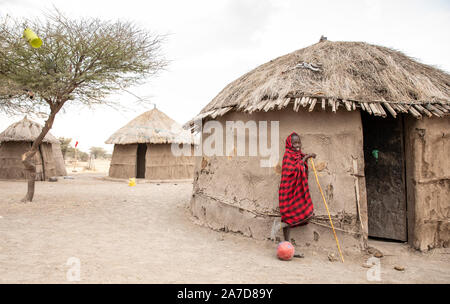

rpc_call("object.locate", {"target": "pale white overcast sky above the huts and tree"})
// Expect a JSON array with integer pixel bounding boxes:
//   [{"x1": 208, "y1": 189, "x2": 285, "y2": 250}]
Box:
[{"x1": 0, "y1": 0, "x2": 450, "y2": 151}]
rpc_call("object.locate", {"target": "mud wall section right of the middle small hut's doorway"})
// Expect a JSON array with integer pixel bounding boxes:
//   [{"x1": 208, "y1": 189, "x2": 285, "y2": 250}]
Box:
[{"x1": 145, "y1": 144, "x2": 195, "y2": 180}]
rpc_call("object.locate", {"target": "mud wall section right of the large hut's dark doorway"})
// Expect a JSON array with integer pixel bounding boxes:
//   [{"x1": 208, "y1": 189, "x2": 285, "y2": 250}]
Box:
[{"x1": 405, "y1": 117, "x2": 450, "y2": 251}]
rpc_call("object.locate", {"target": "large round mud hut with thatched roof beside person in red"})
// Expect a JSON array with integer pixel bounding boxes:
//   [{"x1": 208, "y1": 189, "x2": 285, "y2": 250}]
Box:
[{"x1": 186, "y1": 40, "x2": 450, "y2": 250}]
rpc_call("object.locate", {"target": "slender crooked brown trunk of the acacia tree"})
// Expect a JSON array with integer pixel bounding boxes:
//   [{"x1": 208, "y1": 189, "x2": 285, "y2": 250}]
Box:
[{"x1": 22, "y1": 102, "x2": 64, "y2": 203}]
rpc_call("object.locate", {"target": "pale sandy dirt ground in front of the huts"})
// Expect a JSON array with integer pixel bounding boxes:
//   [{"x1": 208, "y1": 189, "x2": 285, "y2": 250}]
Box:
[{"x1": 0, "y1": 172, "x2": 450, "y2": 283}]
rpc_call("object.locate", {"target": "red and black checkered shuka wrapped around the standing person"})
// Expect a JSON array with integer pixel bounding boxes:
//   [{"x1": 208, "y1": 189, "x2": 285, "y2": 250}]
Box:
[{"x1": 278, "y1": 132, "x2": 314, "y2": 227}]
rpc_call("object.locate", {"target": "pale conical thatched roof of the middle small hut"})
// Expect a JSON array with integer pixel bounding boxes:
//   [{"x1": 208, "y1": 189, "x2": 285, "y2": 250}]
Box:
[{"x1": 105, "y1": 108, "x2": 198, "y2": 145}]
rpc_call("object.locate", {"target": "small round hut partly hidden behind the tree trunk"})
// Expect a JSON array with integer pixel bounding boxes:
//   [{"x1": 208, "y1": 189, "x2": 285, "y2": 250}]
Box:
[{"x1": 0, "y1": 117, "x2": 67, "y2": 181}]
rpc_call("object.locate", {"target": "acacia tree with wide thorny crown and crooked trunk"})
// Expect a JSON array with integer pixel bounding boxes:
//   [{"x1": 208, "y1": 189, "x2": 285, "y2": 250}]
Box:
[{"x1": 0, "y1": 10, "x2": 166, "y2": 202}]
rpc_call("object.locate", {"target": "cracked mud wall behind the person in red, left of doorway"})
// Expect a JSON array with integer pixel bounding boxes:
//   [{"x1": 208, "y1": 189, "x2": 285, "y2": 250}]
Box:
[{"x1": 190, "y1": 110, "x2": 367, "y2": 248}]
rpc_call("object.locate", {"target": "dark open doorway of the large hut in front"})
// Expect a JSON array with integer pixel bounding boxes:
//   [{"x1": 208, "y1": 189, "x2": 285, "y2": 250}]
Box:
[{"x1": 361, "y1": 112, "x2": 408, "y2": 241}]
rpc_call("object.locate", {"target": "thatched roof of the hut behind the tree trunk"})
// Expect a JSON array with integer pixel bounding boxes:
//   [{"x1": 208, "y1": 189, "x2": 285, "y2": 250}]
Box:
[{"x1": 0, "y1": 116, "x2": 59, "y2": 143}]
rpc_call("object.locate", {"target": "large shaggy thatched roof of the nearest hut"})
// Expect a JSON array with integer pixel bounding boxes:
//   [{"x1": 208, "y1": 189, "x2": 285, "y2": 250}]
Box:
[{"x1": 187, "y1": 40, "x2": 450, "y2": 125}]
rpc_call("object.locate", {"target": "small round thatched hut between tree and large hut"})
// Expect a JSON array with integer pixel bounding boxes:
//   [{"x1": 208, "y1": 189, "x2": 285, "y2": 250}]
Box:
[{"x1": 105, "y1": 108, "x2": 198, "y2": 180}]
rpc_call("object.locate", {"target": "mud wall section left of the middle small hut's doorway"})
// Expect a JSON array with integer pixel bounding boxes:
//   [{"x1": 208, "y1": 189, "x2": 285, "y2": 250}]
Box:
[{"x1": 109, "y1": 144, "x2": 137, "y2": 178}]
